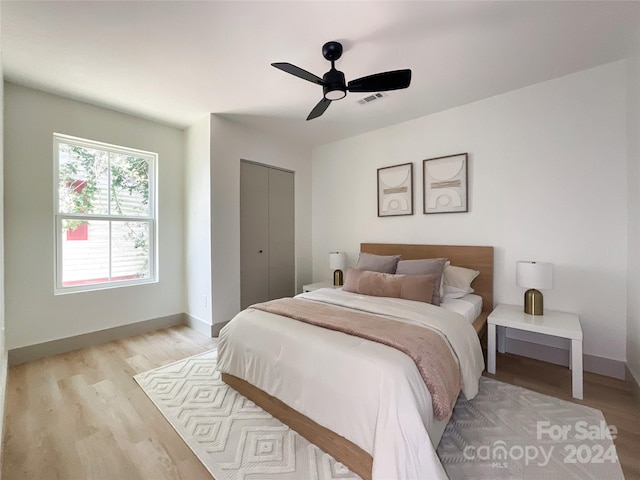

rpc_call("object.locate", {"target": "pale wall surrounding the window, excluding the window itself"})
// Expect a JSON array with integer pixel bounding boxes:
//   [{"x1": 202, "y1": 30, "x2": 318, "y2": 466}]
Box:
[{"x1": 4, "y1": 83, "x2": 185, "y2": 349}]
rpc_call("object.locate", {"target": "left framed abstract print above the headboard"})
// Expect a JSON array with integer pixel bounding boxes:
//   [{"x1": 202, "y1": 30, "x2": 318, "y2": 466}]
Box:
[{"x1": 378, "y1": 163, "x2": 413, "y2": 217}]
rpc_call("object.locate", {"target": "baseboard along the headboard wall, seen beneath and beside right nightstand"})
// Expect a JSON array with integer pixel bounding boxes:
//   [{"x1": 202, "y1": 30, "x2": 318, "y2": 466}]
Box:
[{"x1": 506, "y1": 337, "x2": 626, "y2": 380}]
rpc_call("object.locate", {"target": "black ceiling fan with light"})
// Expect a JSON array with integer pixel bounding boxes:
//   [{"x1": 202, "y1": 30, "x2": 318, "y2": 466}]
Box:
[{"x1": 271, "y1": 42, "x2": 411, "y2": 120}]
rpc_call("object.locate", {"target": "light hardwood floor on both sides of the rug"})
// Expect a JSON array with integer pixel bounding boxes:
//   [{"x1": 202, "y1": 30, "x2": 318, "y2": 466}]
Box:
[{"x1": 2, "y1": 326, "x2": 640, "y2": 480}]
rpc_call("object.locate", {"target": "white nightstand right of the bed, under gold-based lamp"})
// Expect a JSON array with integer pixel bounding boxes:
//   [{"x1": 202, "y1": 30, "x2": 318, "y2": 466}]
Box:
[{"x1": 487, "y1": 305, "x2": 582, "y2": 400}]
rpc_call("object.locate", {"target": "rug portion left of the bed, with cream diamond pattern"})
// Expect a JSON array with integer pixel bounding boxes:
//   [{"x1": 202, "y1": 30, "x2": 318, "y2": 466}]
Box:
[{"x1": 134, "y1": 350, "x2": 360, "y2": 480}]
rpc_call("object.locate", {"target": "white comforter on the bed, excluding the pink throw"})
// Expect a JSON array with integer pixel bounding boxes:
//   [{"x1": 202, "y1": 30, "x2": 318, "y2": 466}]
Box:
[{"x1": 218, "y1": 289, "x2": 484, "y2": 480}]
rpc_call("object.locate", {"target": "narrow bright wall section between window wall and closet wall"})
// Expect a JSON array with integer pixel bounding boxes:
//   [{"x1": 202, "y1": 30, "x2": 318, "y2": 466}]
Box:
[{"x1": 184, "y1": 115, "x2": 212, "y2": 335}]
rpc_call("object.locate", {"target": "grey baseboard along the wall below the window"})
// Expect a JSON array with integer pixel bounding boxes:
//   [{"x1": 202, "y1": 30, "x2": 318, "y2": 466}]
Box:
[{"x1": 9, "y1": 313, "x2": 186, "y2": 365}]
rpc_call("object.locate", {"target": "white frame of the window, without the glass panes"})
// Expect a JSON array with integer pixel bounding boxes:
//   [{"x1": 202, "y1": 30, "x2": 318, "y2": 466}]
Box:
[{"x1": 53, "y1": 133, "x2": 158, "y2": 295}]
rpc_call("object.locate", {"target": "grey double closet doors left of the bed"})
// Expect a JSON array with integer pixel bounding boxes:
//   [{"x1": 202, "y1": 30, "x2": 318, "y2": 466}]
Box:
[{"x1": 240, "y1": 161, "x2": 295, "y2": 309}]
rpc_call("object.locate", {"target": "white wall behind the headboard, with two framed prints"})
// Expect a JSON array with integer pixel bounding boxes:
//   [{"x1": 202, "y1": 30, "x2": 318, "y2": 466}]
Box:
[{"x1": 312, "y1": 61, "x2": 627, "y2": 372}]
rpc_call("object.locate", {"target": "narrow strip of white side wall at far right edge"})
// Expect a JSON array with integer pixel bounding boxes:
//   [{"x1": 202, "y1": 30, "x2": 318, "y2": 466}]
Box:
[{"x1": 627, "y1": 58, "x2": 640, "y2": 384}]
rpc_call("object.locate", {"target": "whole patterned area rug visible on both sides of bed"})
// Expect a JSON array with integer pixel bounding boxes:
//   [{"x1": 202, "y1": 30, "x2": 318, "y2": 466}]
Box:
[{"x1": 134, "y1": 350, "x2": 624, "y2": 480}]
